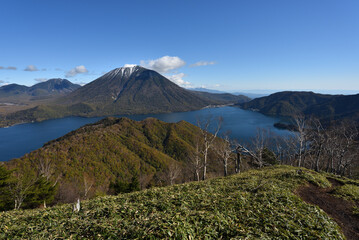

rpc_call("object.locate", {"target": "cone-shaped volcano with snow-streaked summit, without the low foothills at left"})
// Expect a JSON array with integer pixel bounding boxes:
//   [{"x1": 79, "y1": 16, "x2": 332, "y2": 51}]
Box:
[{"x1": 59, "y1": 66, "x2": 245, "y2": 115}]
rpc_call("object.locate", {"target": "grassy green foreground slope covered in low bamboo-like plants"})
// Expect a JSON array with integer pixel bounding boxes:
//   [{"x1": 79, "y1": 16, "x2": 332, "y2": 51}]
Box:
[{"x1": 0, "y1": 166, "x2": 359, "y2": 239}]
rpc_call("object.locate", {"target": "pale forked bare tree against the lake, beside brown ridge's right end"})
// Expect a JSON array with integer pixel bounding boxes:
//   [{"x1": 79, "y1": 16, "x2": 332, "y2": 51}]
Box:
[{"x1": 197, "y1": 117, "x2": 223, "y2": 180}]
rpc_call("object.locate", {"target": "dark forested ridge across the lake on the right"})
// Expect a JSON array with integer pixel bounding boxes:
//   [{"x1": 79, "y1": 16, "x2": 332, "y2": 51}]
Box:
[{"x1": 238, "y1": 91, "x2": 359, "y2": 121}]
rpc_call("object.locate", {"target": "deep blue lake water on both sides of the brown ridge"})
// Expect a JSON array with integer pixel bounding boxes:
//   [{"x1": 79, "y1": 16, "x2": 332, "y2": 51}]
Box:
[{"x1": 0, "y1": 107, "x2": 289, "y2": 161}]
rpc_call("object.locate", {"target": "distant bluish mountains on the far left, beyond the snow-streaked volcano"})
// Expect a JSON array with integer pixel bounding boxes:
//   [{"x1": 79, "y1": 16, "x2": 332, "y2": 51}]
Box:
[{"x1": 0, "y1": 78, "x2": 81, "y2": 102}]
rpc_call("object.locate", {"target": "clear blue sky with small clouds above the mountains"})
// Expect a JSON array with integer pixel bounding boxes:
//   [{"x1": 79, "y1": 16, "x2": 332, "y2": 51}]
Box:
[{"x1": 0, "y1": 0, "x2": 359, "y2": 93}]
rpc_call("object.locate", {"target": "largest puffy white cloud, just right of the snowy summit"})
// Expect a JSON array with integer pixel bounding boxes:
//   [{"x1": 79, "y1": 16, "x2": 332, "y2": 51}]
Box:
[{"x1": 140, "y1": 56, "x2": 186, "y2": 73}]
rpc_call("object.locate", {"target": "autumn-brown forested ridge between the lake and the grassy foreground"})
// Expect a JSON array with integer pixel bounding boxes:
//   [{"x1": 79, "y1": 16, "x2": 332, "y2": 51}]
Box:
[{"x1": 6, "y1": 118, "x2": 222, "y2": 202}]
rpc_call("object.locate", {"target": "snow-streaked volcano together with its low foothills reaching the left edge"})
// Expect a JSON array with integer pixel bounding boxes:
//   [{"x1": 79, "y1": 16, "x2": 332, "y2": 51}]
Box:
[{"x1": 0, "y1": 66, "x2": 250, "y2": 126}]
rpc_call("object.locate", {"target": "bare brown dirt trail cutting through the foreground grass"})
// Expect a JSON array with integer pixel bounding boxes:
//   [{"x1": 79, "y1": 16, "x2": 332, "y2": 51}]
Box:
[{"x1": 297, "y1": 178, "x2": 359, "y2": 240}]
